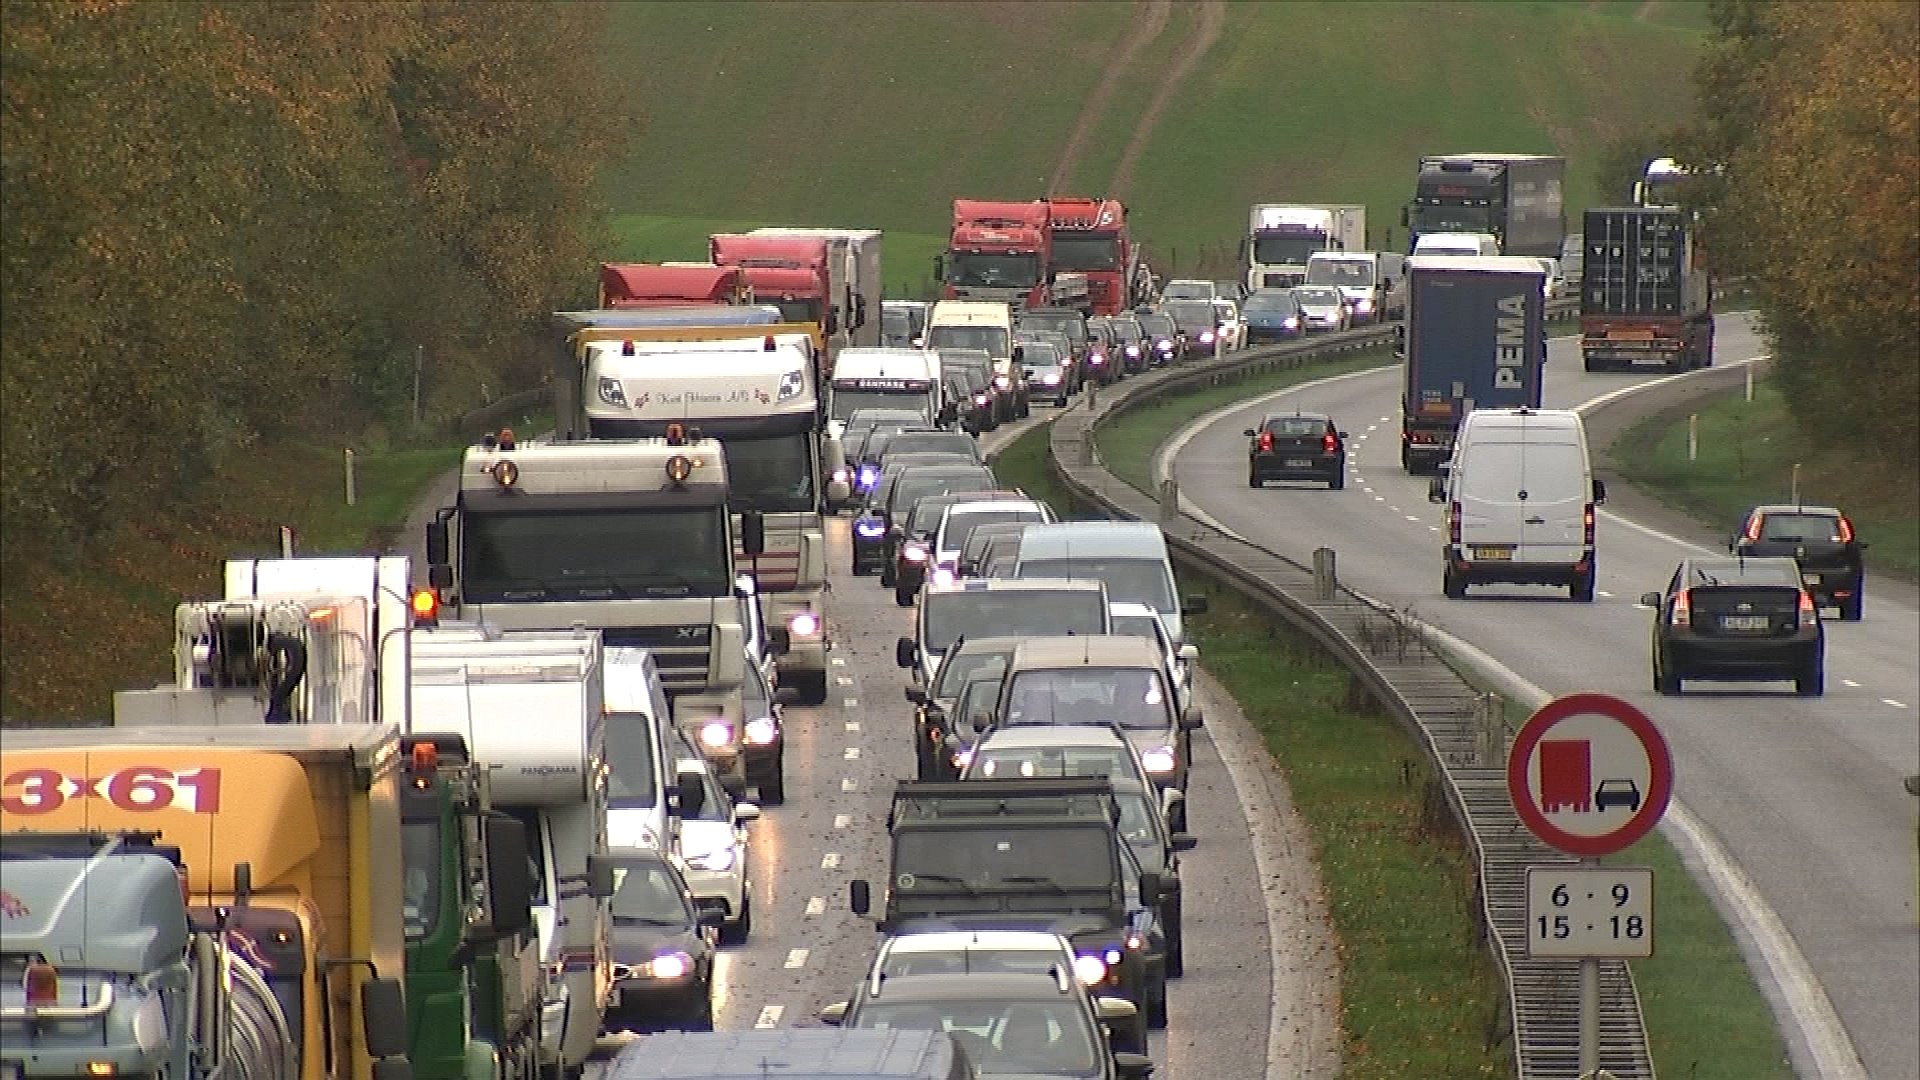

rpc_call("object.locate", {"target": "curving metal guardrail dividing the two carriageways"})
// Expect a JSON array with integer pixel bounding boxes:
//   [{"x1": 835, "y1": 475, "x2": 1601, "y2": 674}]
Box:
[{"x1": 1048, "y1": 300, "x2": 1655, "y2": 1080}]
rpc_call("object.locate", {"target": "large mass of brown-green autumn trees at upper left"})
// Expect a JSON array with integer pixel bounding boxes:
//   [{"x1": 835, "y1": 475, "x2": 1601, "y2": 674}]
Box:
[{"x1": 0, "y1": 0, "x2": 636, "y2": 548}]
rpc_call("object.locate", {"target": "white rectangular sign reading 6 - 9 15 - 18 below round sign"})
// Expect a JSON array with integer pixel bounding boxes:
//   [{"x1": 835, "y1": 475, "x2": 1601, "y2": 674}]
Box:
[{"x1": 1526, "y1": 867, "x2": 1653, "y2": 959}]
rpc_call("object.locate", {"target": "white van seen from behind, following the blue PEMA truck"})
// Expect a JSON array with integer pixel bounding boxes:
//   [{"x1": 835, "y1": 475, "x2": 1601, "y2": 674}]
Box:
[{"x1": 1427, "y1": 409, "x2": 1607, "y2": 601}]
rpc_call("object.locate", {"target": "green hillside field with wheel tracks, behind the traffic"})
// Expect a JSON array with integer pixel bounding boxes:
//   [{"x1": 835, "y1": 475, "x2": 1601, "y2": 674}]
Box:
[{"x1": 603, "y1": 0, "x2": 1705, "y2": 272}]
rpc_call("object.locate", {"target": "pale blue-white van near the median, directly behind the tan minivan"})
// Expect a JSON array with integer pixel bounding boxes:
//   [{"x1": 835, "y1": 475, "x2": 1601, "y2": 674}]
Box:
[{"x1": 1014, "y1": 521, "x2": 1206, "y2": 648}]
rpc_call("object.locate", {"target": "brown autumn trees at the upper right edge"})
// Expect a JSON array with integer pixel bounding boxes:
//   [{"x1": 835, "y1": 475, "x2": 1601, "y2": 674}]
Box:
[{"x1": 1684, "y1": 0, "x2": 1920, "y2": 465}]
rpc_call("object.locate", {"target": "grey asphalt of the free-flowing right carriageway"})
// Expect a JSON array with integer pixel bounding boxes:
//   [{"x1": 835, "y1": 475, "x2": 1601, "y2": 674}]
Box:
[{"x1": 1171, "y1": 317, "x2": 1920, "y2": 1078}]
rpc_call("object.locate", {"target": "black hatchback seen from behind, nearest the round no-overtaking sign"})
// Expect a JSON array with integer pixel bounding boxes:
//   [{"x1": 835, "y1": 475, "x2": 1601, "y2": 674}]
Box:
[{"x1": 1640, "y1": 555, "x2": 1826, "y2": 698}]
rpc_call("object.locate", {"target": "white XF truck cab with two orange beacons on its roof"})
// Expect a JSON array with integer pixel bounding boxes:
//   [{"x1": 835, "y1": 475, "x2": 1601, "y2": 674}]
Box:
[{"x1": 426, "y1": 425, "x2": 766, "y2": 768}]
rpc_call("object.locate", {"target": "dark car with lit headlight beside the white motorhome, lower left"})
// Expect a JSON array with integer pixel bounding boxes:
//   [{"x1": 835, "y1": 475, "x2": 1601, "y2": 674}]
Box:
[{"x1": 601, "y1": 847, "x2": 724, "y2": 1032}]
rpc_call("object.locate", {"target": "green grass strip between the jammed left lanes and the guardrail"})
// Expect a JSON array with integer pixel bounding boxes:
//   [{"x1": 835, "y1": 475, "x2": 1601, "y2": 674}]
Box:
[{"x1": 995, "y1": 427, "x2": 1513, "y2": 1080}]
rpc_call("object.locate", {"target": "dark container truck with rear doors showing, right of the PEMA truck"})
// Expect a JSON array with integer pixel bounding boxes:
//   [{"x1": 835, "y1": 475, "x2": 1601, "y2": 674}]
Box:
[{"x1": 1580, "y1": 206, "x2": 1713, "y2": 373}]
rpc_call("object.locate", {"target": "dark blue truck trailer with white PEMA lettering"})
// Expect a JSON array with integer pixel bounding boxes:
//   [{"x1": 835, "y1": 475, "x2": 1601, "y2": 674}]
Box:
[{"x1": 1396, "y1": 256, "x2": 1548, "y2": 473}]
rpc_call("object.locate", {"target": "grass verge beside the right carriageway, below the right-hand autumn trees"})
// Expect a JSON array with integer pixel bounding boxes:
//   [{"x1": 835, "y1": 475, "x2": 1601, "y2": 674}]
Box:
[{"x1": 1613, "y1": 379, "x2": 1920, "y2": 580}]
